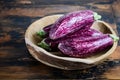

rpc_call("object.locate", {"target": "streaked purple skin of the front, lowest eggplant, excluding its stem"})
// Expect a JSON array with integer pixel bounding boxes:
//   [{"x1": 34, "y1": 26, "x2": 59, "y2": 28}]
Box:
[{"x1": 58, "y1": 34, "x2": 113, "y2": 58}]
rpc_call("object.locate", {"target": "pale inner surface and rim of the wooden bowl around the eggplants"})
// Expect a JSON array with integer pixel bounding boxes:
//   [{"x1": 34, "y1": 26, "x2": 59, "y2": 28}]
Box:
[{"x1": 25, "y1": 14, "x2": 117, "y2": 64}]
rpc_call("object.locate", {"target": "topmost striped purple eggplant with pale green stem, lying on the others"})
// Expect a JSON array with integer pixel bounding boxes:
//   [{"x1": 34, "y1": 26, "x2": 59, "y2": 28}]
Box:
[{"x1": 49, "y1": 10, "x2": 101, "y2": 40}]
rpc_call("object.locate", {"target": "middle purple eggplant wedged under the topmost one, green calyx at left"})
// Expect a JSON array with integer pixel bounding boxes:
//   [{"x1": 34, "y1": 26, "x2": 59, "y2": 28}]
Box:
[{"x1": 38, "y1": 29, "x2": 103, "y2": 51}]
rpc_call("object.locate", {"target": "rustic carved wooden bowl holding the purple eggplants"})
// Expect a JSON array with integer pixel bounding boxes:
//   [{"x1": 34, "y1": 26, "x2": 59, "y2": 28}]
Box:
[{"x1": 25, "y1": 15, "x2": 117, "y2": 70}]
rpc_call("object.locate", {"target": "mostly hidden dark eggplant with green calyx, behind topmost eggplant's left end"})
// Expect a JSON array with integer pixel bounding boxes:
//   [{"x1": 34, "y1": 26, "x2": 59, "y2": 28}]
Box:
[{"x1": 37, "y1": 24, "x2": 53, "y2": 38}]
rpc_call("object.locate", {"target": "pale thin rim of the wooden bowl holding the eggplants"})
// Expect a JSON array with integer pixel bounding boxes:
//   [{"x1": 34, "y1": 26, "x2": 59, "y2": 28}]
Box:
[{"x1": 25, "y1": 14, "x2": 118, "y2": 64}]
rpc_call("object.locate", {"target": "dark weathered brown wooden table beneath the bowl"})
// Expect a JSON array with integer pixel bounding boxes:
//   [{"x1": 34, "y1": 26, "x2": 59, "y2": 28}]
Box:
[{"x1": 0, "y1": 0, "x2": 120, "y2": 80}]
